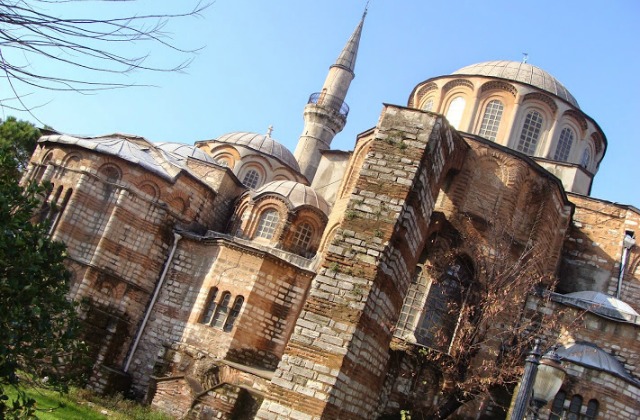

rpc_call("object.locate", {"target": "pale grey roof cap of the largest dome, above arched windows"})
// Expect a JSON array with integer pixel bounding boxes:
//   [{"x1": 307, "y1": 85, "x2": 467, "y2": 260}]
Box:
[{"x1": 451, "y1": 61, "x2": 580, "y2": 109}]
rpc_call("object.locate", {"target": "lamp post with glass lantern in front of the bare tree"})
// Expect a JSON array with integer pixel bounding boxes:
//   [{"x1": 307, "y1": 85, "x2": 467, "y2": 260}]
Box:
[{"x1": 510, "y1": 339, "x2": 565, "y2": 420}]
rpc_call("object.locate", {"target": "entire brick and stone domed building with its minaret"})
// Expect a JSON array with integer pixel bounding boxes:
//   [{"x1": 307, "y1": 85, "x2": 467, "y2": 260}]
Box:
[{"x1": 25, "y1": 6, "x2": 640, "y2": 419}]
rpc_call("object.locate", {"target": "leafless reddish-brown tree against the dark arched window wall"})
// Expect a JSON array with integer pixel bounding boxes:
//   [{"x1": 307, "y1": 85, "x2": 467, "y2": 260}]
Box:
[{"x1": 392, "y1": 208, "x2": 572, "y2": 419}]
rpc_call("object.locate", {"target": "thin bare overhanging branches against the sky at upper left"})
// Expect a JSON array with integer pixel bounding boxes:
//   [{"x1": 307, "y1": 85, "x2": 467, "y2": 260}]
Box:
[{"x1": 0, "y1": 0, "x2": 211, "y2": 110}]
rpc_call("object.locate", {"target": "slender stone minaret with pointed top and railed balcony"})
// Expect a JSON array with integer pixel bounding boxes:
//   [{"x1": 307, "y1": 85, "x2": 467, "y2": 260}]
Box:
[{"x1": 294, "y1": 9, "x2": 367, "y2": 182}]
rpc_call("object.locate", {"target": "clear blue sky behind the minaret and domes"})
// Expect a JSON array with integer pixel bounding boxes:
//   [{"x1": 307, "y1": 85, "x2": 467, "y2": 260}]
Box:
[{"x1": 5, "y1": 0, "x2": 640, "y2": 207}]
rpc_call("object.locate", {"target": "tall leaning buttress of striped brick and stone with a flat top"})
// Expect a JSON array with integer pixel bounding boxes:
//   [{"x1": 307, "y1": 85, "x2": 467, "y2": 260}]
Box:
[{"x1": 258, "y1": 106, "x2": 466, "y2": 418}]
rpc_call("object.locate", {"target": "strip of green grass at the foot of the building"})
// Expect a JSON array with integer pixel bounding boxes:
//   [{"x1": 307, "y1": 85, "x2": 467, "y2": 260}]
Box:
[{"x1": 5, "y1": 387, "x2": 171, "y2": 420}]
